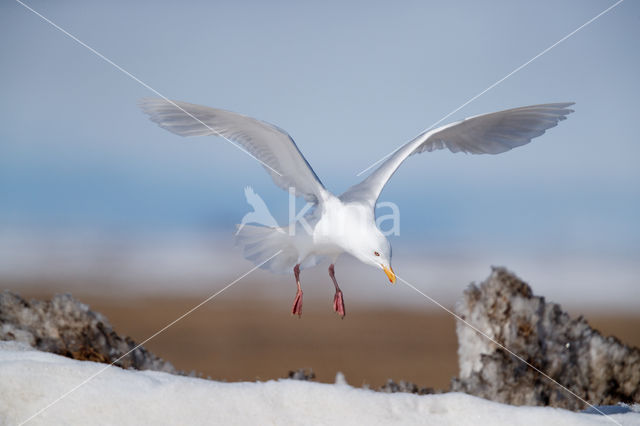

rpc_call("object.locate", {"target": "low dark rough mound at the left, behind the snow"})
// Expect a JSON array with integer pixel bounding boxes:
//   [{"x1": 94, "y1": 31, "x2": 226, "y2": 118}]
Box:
[{"x1": 0, "y1": 291, "x2": 180, "y2": 374}]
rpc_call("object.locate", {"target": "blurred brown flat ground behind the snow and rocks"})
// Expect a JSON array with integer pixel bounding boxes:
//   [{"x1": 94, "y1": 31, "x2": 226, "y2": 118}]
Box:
[{"x1": 10, "y1": 292, "x2": 640, "y2": 389}]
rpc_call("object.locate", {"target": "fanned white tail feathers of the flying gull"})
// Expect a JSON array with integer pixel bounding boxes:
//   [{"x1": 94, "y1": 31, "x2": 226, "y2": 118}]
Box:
[{"x1": 236, "y1": 225, "x2": 298, "y2": 273}]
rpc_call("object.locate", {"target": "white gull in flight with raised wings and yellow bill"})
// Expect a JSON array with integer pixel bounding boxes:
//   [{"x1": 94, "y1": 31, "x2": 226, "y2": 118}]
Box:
[{"x1": 139, "y1": 98, "x2": 573, "y2": 318}]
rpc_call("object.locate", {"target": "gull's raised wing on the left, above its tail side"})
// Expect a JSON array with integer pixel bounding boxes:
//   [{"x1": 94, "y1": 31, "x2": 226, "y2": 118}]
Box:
[{"x1": 139, "y1": 98, "x2": 327, "y2": 203}]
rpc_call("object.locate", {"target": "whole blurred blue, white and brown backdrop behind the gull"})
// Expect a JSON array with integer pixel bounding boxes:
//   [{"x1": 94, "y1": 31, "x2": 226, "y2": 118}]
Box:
[{"x1": 0, "y1": 0, "x2": 640, "y2": 387}]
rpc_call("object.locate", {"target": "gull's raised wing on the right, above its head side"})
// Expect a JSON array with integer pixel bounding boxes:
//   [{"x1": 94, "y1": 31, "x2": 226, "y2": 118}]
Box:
[{"x1": 340, "y1": 102, "x2": 573, "y2": 206}]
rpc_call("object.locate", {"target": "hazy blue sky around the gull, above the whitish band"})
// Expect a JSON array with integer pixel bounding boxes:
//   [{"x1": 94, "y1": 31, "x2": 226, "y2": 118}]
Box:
[{"x1": 0, "y1": 0, "x2": 640, "y2": 257}]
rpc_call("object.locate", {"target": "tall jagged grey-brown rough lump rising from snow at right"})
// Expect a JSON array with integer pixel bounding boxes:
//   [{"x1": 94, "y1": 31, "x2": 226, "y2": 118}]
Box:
[{"x1": 452, "y1": 268, "x2": 640, "y2": 410}]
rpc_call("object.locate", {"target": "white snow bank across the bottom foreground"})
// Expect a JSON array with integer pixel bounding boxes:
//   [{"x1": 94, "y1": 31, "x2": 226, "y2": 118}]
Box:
[{"x1": 0, "y1": 342, "x2": 640, "y2": 425}]
